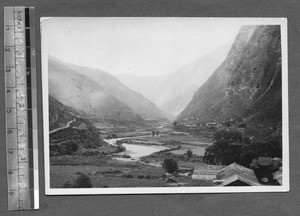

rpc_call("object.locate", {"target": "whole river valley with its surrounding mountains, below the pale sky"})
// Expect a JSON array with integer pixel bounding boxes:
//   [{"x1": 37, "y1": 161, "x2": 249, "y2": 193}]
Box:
[{"x1": 49, "y1": 26, "x2": 282, "y2": 188}]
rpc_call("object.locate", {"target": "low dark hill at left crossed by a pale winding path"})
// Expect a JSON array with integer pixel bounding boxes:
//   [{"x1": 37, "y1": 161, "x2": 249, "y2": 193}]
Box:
[{"x1": 49, "y1": 96, "x2": 109, "y2": 156}]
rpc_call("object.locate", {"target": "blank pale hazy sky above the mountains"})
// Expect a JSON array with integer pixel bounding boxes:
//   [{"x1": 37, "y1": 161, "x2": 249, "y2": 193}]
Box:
[{"x1": 41, "y1": 18, "x2": 241, "y2": 75}]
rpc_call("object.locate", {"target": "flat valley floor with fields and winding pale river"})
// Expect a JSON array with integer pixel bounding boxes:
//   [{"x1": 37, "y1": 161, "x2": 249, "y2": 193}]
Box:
[{"x1": 50, "y1": 125, "x2": 213, "y2": 188}]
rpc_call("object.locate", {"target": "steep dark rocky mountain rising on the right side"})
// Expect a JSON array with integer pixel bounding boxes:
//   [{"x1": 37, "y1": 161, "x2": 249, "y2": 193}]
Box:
[{"x1": 178, "y1": 26, "x2": 281, "y2": 133}]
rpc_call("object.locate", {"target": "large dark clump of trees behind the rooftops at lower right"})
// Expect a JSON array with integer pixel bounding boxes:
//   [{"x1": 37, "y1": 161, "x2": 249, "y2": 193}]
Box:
[{"x1": 203, "y1": 131, "x2": 282, "y2": 167}]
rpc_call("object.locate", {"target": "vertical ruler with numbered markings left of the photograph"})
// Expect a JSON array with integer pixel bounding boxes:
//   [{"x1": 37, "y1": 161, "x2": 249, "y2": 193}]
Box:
[{"x1": 3, "y1": 7, "x2": 39, "y2": 210}]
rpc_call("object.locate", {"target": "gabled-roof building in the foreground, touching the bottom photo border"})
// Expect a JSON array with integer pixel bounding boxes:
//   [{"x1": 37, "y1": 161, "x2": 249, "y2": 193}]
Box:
[{"x1": 214, "y1": 163, "x2": 260, "y2": 186}]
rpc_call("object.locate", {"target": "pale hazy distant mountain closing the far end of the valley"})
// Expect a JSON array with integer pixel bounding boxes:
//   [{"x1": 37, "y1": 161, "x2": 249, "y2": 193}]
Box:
[{"x1": 117, "y1": 46, "x2": 230, "y2": 116}]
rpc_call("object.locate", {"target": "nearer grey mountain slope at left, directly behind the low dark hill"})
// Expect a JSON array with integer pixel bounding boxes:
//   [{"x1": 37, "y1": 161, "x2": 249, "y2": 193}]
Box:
[{"x1": 48, "y1": 58, "x2": 147, "y2": 126}]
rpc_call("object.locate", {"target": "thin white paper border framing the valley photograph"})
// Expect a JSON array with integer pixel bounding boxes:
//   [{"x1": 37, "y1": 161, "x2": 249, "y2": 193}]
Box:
[{"x1": 40, "y1": 17, "x2": 290, "y2": 195}]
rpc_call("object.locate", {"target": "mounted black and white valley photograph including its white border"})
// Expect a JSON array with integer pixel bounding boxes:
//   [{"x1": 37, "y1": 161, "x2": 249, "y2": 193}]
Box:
[{"x1": 41, "y1": 17, "x2": 289, "y2": 195}]
